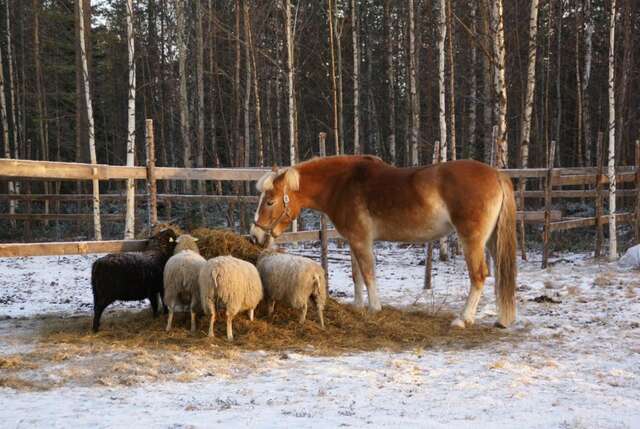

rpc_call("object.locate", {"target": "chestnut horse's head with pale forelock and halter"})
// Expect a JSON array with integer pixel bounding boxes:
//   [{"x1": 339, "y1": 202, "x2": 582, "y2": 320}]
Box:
[{"x1": 250, "y1": 167, "x2": 300, "y2": 247}]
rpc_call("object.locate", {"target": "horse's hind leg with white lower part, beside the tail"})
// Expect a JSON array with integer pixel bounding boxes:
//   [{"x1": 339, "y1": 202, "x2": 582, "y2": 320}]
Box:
[{"x1": 451, "y1": 240, "x2": 488, "y2": 328}]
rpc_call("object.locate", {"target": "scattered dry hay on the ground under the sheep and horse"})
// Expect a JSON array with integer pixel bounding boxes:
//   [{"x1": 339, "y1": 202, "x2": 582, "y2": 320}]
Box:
[{"x1": 0, "y1": 299, "x2": 515, "y2": 390}]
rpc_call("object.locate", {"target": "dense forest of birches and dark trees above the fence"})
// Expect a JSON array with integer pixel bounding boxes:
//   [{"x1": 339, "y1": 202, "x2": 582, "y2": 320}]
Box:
[{"x1": 0, "y1": 0, "x2": 640, "y2": 181}]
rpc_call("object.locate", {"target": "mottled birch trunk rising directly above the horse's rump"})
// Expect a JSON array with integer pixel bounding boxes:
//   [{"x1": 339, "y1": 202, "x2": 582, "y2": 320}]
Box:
[{"x1": 491, "y1": 0, "x2": 509, "y2": 168}]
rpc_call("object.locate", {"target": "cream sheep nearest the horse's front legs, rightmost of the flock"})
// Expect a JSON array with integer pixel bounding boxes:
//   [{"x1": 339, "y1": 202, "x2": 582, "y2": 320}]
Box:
[{"x1": 257, "y1": 250, "x2": 327, "y2": 329}]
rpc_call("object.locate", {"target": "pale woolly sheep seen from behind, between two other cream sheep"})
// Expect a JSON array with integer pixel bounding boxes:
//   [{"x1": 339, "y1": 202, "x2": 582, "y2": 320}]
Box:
[{"x1": 198, "y1": 256, "x2": 263, "y2": 341}]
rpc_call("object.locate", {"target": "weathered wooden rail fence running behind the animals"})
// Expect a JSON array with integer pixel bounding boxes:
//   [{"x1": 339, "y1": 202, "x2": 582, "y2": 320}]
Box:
[{"x1": 0, "y1": 127, "x2": 640, "y2": 266}]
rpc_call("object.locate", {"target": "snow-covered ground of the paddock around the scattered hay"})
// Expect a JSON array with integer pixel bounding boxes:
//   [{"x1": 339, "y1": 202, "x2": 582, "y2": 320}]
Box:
[{"x1": 0, "y1": 245, "x2": 640, "y2": 429}]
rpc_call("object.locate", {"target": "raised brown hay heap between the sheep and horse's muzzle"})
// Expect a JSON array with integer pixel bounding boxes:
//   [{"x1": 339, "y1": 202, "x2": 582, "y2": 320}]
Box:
[{"x1": 190, "y1": 228, "x2": 262, "y2": 264}]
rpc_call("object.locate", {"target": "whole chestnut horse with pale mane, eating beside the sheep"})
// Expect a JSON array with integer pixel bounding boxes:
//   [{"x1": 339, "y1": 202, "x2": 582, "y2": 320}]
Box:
[{"x1": 251, "y1": 156, "x2": 517, "y2": 328}]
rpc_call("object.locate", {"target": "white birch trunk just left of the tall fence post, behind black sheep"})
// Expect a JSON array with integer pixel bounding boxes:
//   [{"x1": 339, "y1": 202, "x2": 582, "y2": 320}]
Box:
[{"x1": 124, "y1": 0, "x2": 136, "y2": 240}]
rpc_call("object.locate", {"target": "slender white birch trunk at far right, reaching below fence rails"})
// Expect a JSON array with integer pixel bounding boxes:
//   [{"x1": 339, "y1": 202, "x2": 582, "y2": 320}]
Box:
[{"x1": 607, "y1": 0, "x2": 618, "y2": 261}]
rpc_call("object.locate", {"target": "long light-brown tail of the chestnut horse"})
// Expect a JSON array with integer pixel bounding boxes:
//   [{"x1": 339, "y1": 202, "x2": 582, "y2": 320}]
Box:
[{"x1": 492, "y1": 173, "x2": 518, "y2": 328}]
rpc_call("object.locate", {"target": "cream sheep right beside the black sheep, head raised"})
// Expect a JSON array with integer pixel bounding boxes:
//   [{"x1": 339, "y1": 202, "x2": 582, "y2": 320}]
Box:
[{"x1": 164, "y1": 234, "x2": 206, "y2": 332}]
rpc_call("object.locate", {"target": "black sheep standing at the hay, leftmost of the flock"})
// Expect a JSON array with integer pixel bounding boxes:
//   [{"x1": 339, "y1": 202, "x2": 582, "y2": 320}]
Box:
[{"x1": 91, "y1": 229, "x2": 176, "y2": 332}]
